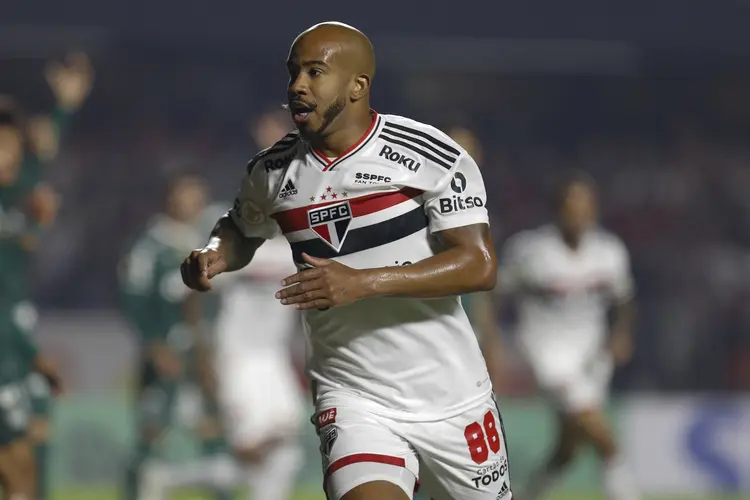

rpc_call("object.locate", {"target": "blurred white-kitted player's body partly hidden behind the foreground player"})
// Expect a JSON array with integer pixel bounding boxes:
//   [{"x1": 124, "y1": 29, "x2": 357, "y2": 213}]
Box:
[{"x1": 214, "y1": 234, "x2": 303, "y2": 500}]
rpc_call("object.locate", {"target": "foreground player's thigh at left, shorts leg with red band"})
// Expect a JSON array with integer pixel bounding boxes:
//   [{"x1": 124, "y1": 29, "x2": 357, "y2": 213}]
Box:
[{"x1": 314, "y1": 405, "x2": 419, "y2": 500}]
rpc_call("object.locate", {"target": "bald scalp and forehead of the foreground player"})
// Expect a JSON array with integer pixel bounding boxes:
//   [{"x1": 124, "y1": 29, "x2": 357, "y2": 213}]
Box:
[{"x1": 292, "y1": 21, "x2": 375, "y2": 80}]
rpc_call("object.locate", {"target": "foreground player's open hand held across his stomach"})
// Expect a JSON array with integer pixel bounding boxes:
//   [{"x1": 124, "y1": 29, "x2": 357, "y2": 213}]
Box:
[{"x1": 276, "y1": 253, "x2": 364, "y2": 310}]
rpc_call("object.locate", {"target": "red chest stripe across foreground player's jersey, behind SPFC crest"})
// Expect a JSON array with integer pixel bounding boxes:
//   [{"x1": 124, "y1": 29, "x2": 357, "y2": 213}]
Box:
[{"x1": 273, "y1": 188, "x2": 424, "y2": 234}]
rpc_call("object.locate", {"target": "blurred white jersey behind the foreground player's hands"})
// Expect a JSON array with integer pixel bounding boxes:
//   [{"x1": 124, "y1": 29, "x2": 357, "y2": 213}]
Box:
[{"x1": 216, "y1": 237, "x2": 301, "y2": 359}]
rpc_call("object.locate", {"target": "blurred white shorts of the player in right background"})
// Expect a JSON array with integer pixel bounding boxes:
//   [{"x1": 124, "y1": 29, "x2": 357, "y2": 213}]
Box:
[{"x1": 526, "y1": 351, "x2": 614, "y2": 413}]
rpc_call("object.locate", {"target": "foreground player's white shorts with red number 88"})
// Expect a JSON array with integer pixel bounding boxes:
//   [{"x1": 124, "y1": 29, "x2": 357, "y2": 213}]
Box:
[{"x1": 313, "y1": 393, "x2": 512, "y2": 500}]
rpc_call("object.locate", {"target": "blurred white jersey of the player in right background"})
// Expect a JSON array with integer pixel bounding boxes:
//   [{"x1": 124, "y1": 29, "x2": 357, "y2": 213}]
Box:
[{"x1": 498, "y1": 225, "x2": 633, "y2": 367}]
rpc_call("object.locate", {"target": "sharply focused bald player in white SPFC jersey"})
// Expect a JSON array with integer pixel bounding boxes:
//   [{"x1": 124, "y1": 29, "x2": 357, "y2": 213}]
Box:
[{"x1": 181, "y1": 23, "x2": 511, "y2": 500}]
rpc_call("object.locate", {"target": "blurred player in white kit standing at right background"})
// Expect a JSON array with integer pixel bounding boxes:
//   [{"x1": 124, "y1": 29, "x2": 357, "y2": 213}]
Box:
[{"x1": 499, "y1": 173, "x2": 638, "y2": 500}]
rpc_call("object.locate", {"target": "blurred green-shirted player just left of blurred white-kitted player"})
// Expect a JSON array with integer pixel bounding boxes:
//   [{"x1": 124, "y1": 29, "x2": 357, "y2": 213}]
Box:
[{"x1": 120, "y1": 175, "x2": 232, "y2": 498}]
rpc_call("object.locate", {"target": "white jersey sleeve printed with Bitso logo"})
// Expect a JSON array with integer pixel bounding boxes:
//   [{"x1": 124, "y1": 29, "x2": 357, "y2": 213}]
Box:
[{"x1": 424, "y1": 152, "x2": 489, "y2": 233}]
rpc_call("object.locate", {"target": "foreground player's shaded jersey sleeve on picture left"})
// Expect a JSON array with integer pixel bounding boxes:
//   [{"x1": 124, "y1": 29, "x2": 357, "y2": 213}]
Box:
[{"x1": 229, "y1": 161, "x2": 281, "y2": 240}]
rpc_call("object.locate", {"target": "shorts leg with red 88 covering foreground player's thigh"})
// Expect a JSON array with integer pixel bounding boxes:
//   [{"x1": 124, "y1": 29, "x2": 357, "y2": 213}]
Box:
[{"x1": 414, "y1": 397, "x2": 511, "y2": 500}]
